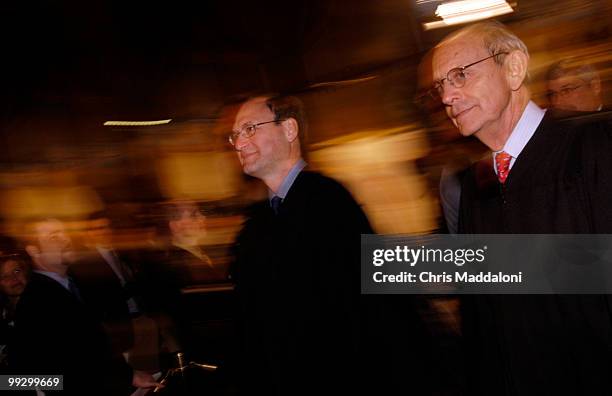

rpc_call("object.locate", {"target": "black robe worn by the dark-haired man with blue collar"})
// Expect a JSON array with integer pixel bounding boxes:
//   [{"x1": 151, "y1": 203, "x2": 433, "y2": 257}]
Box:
[{"x1": 232, "y1": 171, "x2": 432, "y2": 395}]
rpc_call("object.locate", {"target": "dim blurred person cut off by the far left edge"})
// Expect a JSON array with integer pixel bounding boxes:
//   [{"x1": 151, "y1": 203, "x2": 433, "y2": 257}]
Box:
[{"x1": 0, "y1": 248, "x2": 29, "y2": 371}]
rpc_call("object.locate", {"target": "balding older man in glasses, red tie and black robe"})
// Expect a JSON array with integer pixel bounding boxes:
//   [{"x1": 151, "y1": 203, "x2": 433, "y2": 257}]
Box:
[{"x1": 432, "y1": 22, "x2": 612, "y2": 395}]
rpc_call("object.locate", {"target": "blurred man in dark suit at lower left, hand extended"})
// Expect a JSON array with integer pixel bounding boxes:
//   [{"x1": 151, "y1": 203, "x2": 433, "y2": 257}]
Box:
[{"x1": 14, "y1": 218, "x2": 157, "y2": 395}]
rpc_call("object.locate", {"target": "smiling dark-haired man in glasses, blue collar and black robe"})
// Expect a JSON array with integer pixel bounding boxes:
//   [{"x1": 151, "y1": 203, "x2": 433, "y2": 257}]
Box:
[{"x1": 229, "y1": 96, "x2": 430, "y2": 395}]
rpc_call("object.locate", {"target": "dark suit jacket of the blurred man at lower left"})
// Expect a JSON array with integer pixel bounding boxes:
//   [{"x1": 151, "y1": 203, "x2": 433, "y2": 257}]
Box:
[{"x1": 14, "y1": 273, "x2": 132, "y2": 395}]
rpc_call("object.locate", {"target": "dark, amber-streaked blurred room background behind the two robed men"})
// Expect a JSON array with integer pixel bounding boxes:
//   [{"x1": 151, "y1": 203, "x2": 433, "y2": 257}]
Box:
[{"x1": 0, "y1": 0, "x2": 612, "y2": 232}]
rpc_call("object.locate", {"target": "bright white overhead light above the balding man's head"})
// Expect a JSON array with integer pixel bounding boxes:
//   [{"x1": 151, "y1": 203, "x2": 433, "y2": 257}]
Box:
[{"x1": 423, "y1": 0, "x2": 514, "y2": 30}]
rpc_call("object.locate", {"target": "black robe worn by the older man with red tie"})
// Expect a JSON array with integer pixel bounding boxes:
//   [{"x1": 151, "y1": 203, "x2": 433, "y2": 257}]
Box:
[{"x1": 460, "y1": 114, "x2": 612, "y2": 395}]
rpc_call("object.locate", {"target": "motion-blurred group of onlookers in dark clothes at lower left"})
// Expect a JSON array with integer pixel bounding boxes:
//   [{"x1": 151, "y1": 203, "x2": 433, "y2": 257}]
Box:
[{"x1": 0, "y1": 200, "x2": 229, "y2": 394}]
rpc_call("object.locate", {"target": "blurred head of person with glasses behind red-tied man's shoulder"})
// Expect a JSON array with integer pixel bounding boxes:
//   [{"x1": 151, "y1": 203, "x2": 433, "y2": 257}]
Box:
[{"x1": 546, "y1": 59, "x2": 603, "y2": 111}]
